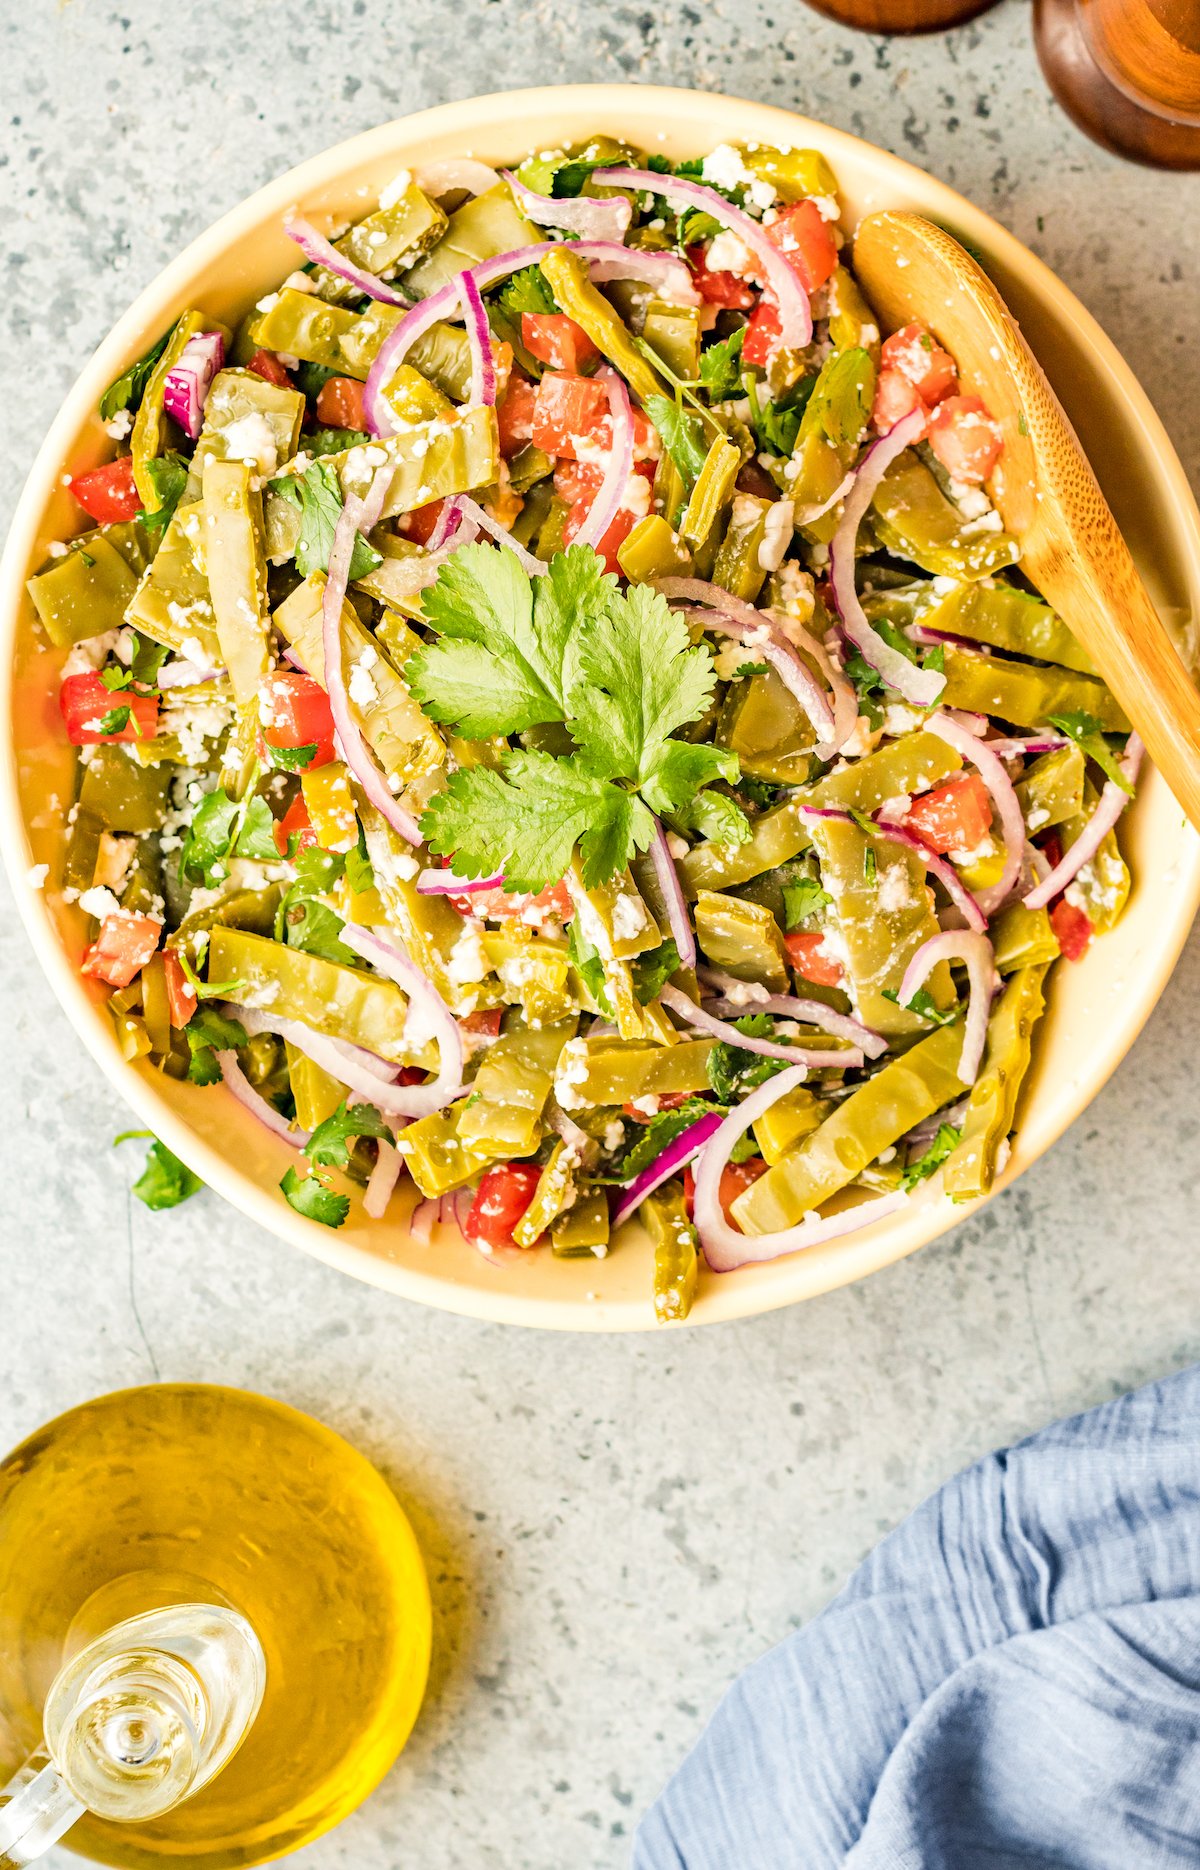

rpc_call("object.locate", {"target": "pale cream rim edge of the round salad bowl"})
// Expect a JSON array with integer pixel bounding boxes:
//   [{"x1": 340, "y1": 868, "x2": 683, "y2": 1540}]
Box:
[{"x1": 0, "y1": 84, "x2": 1200, "y2": 1331}]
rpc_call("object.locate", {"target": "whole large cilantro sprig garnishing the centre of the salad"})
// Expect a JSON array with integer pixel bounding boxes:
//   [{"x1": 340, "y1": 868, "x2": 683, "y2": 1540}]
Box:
[{"x1": 406, "y1": 546, "x2": 748, "y2": 890}]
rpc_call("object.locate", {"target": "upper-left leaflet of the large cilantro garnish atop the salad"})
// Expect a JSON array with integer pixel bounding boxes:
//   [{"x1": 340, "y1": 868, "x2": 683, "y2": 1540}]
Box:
[{"x1": 406, "y1": 546, "x2": 617, "y2": 741}]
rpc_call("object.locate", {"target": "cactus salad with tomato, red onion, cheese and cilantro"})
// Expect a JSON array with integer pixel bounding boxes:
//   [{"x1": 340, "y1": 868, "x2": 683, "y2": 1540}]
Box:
[{"x1": 30, "y1": 137, "x2": 1140, "y2": 1318}]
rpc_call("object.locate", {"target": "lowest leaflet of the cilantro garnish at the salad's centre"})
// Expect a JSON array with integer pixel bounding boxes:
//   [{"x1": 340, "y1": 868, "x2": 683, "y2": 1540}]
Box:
[{"x1": 421, "y1": 752, "x2": 654, "y2": 892}]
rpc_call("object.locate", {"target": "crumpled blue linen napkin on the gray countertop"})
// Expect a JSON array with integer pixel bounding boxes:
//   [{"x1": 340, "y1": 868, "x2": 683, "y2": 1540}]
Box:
[{"x1": 634, "y1": 1367, "x2": 1200, "y2": 1870}]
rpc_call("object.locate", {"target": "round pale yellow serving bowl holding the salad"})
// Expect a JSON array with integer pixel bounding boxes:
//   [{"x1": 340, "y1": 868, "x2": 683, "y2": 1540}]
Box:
[{"x1": 0, "y1": 84, "x2": 1200, "y2": 1331}]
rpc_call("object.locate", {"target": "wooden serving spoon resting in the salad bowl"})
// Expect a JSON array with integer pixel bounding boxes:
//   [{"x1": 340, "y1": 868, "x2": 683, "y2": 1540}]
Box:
[{"x1": 854, "y1": 209, "x2": 1200, "y2": 830}]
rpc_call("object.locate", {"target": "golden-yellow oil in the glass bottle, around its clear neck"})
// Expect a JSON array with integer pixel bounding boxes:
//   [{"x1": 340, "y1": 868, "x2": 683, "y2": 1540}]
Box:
[{"x1": 0, "y1": 1384, "x2": 430, "y2": 1870}]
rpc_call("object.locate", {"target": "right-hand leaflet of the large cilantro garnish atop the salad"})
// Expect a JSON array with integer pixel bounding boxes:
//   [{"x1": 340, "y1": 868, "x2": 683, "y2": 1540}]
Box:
[{"x1": 570, "y1": 585, "x2": 717, "y2": 789}]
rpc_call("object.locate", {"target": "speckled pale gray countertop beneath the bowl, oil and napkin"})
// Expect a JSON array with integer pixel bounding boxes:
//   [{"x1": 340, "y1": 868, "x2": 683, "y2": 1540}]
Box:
[{"x1": 0, "y1": 0, "x2": 1200, "y2": 1870}]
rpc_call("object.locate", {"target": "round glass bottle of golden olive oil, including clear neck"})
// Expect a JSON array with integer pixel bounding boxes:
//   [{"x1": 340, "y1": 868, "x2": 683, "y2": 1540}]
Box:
[{"x1": 0, "y1": 1384, "x2": 430, "y2": 1870}]
